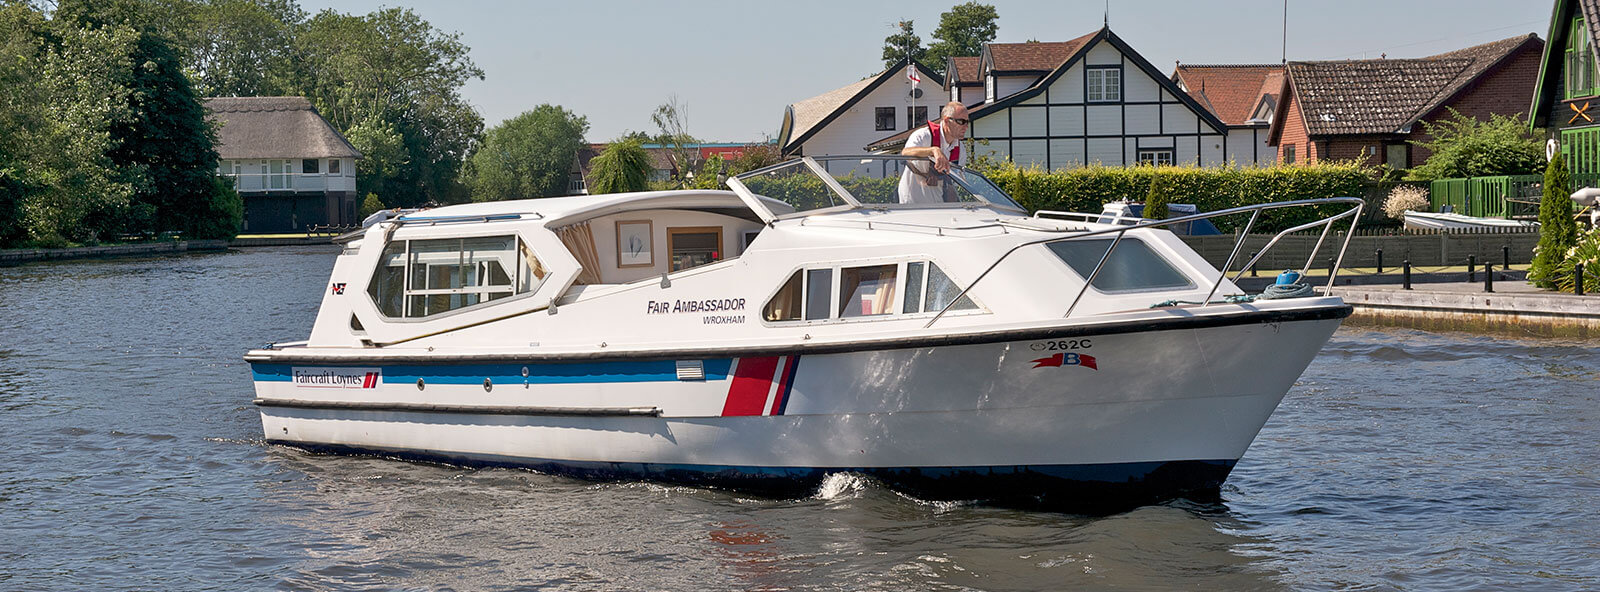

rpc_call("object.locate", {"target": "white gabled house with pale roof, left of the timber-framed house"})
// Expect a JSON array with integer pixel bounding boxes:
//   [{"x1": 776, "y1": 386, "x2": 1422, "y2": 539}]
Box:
[{"x1": 778, "y1": 61, "x2": 947, "y2": 157}]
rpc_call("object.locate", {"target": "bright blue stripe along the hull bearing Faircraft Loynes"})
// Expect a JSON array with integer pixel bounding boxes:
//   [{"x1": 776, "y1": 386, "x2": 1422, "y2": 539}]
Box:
[{"x1": 250, "y1": 358, "x2": 733, "y2": 384}]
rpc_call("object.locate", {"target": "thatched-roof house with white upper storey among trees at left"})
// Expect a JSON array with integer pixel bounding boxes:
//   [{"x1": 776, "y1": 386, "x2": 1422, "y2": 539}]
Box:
[{"x1": 205, "y1": 96, "x2": 362, "y2": 234}]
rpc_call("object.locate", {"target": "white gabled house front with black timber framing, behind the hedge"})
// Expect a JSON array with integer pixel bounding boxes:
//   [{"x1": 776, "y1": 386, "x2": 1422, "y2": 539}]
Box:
[{"x1": 867, "y1": 27, "x2": 1256, "y2": 170}]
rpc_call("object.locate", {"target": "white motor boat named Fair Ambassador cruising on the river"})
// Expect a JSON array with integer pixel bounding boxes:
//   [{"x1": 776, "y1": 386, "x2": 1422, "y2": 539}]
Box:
[{"x1": 245, "y1": 157, "x2": 1360, "y2": 507}]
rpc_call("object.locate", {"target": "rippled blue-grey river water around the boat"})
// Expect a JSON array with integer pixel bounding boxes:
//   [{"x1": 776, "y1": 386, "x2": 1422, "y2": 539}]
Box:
[{"x1": 0, "y1": 246, "x2": 1600, "y2": 590}]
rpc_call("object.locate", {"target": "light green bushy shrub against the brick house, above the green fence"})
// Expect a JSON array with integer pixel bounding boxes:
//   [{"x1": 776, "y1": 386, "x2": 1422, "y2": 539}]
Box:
[{"x1": 1406, "y1": 109, "x2": 1544, "y2": 181}]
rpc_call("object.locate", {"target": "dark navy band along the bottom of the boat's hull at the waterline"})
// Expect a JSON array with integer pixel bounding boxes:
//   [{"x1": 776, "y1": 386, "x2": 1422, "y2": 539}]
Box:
[{"x1": 267, "y1": 438, "x2": 1237, "y2": 514}]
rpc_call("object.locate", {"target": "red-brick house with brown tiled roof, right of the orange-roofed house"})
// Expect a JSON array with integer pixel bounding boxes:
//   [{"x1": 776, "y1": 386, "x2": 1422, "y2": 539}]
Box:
[{"x1": 1267, "y1": 34, "x2": 1544, "y2": 170}]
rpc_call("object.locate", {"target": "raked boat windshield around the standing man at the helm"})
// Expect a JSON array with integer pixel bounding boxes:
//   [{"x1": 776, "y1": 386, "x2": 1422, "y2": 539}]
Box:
[{"x1": 730, "y1": 155, "x2": 1026, "y2": 218}]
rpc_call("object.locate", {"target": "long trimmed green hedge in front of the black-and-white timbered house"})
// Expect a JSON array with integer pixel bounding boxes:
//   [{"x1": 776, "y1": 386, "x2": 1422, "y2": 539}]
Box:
[{"x1": 984, "y1": 162, "x2": 1371, "y2": 232}]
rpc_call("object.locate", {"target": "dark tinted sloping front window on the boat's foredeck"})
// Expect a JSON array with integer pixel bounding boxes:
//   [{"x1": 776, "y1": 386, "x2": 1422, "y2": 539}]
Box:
[{"x1": 1046, "y1": 238, "x2": 1194, "y2": 291}]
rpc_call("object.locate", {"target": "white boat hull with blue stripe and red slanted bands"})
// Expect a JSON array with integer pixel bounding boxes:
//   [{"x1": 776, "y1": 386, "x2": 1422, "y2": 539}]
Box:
[{"x1": 254, "y1": 304, "x2": 1349, "y2": 509}]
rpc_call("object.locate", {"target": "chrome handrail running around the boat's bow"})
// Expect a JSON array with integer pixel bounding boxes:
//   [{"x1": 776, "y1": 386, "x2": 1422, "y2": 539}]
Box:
[{"x1": 923, "y1": 197, "x2": 1366, "y2": 328}]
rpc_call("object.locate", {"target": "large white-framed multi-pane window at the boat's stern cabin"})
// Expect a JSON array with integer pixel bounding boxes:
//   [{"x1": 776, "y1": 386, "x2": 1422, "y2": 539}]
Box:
[{"x1": 366, "y1": 235, "x2": 549, "y2": 318}]
